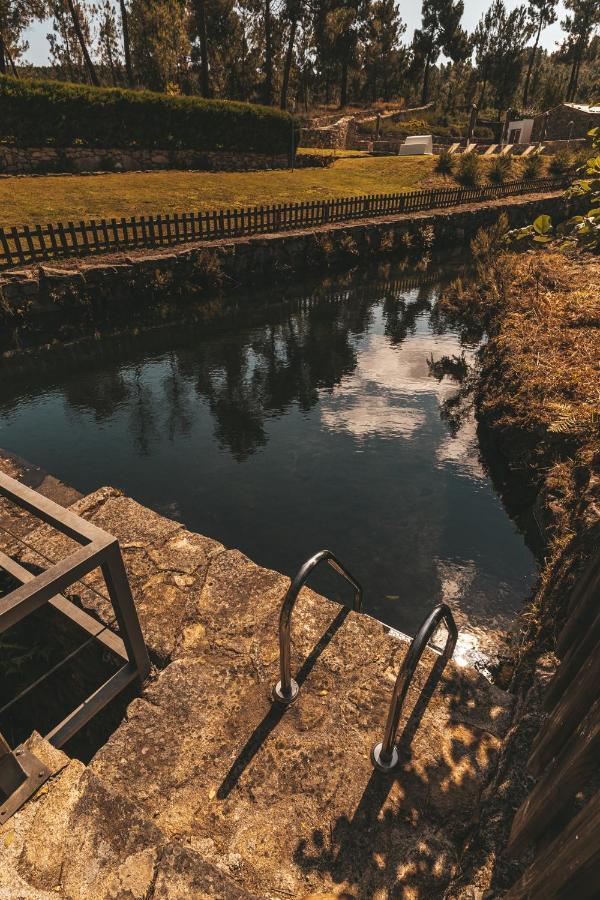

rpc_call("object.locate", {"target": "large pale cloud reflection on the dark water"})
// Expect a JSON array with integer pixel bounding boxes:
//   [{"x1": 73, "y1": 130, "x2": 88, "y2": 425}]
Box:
[{"x1": 320, "y1": 334, "x2": 478, "y2": 440}]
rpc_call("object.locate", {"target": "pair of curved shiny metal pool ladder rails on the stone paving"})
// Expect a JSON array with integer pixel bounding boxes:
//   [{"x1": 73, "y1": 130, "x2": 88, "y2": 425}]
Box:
[{"x1": 273, "y1": 550, "x2": 458, "y2": 772}]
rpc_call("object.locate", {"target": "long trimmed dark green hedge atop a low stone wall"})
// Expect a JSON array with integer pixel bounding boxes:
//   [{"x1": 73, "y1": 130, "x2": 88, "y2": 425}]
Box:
[{"x1": 0, "y1": 76, "x2": 295, "y2": 154}]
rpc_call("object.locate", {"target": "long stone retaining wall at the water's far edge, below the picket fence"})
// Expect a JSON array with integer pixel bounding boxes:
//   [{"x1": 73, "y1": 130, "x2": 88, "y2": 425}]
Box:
[{"x1": 0, "y1": 194, "x2": 573, "y2": 322}]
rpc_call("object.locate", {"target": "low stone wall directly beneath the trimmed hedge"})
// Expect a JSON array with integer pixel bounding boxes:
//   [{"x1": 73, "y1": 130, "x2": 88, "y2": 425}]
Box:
[{"x1": 0, "y1": 145, "x2": 331, "y2": 175}]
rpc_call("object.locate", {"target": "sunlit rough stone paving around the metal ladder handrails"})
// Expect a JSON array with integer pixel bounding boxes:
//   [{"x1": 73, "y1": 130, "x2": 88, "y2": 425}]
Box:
[{"x1": 0, "y1": 460, "x2": 511, "y2": 900}]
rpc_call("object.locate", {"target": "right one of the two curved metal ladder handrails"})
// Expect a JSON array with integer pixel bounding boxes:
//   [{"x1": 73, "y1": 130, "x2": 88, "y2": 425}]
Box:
[{"x1": 371, "y1": 603, "x2": 458, "y2": 772}]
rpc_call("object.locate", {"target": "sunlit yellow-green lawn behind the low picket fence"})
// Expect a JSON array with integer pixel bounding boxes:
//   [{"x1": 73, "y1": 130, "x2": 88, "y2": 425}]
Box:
[{"x1": 0, "y1": 156, "x2": 440, "y2": 226}]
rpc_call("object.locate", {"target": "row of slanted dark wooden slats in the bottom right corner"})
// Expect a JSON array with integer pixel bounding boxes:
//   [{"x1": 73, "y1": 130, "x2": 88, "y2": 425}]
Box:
[{"x1": 505, "y1": 553, "x2": 600, "y2": 900}]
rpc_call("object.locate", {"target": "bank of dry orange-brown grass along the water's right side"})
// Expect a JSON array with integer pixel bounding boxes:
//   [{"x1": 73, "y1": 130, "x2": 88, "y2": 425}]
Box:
[{"x1": 443, "y1": 244, "x2": 600, "y2": 897}]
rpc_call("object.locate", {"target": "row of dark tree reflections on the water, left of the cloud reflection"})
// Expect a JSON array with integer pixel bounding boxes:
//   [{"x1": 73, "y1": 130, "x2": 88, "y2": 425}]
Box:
[{"x1": 21, "y1": 270, "x2": 458, "y2": 460}]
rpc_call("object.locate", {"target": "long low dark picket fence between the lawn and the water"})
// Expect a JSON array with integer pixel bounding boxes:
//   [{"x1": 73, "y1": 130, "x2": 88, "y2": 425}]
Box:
[{"x1": 0, "y1": 176, "x2": 566, "y2": 269}]
